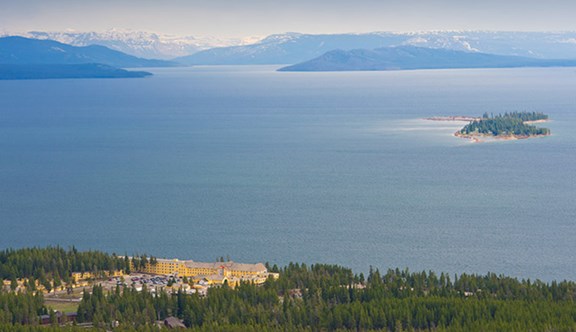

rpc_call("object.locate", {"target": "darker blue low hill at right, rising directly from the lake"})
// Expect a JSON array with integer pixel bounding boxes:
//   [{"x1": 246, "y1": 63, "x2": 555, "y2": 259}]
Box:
[{"x1": 279, "y1": 46, "x2": 576, "y2": 71}]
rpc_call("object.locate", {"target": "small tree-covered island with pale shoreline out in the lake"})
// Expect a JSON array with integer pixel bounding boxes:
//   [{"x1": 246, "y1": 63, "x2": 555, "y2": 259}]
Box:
[{"x1": 455, "y1": 112, "x2": 550, "y2": 139}]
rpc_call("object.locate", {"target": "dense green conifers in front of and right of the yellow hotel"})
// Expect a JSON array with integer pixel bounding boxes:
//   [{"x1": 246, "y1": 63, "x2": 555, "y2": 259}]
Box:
[{"x1": 71, "y1": 263, "x2": 576, "y2": 331}]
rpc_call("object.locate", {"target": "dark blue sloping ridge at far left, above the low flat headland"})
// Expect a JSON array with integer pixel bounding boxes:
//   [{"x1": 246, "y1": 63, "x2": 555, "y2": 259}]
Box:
[{"x1": 0, "y1": 37, "x2": 177, "y2": 68}]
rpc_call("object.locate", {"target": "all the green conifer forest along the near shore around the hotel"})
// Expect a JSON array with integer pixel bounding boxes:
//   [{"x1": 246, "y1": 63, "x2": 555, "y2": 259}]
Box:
[{"x1": 0, "y1": 247, "x2": 576, "y2": 331}]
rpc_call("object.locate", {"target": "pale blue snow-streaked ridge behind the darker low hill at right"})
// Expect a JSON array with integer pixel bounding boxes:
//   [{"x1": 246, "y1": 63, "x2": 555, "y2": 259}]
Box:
[{"x1": 175, "y1": 31, "x2": 576, "y2": 65}]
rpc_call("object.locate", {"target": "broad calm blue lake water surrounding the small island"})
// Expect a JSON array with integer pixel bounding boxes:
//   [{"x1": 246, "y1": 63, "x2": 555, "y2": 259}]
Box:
[{"x1": 0, "y1": 66, "x2": 576, "y2": 280}]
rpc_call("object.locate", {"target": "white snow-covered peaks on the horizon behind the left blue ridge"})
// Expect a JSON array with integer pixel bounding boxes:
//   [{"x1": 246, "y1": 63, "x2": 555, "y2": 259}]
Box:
[{"x1": 0, "y1": 29, "x2": 259, "y2": 59}]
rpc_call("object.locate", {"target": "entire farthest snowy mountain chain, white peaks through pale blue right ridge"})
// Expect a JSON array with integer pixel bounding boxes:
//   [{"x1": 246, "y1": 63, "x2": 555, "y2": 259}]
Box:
[{"x1": 0, "y1": 29, "x2": 576, "y2": 65}]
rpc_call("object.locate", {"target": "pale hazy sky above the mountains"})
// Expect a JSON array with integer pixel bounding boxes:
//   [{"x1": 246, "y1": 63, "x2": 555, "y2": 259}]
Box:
[{"x1": 0, "y1": 0, "x2": 576, "y2": 37}]
